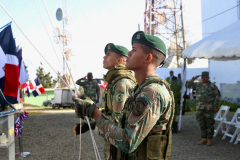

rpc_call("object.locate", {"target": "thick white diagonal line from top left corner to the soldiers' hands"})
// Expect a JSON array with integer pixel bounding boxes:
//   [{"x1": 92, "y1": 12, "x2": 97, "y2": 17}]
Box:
[{"x1": 0, "y1": 3, "x2": 74, "y2": 95}]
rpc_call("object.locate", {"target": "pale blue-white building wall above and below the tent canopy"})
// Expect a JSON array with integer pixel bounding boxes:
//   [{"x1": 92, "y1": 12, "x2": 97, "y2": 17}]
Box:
[{"x1": 201, "y1": 0, "x2": 240, "y2": 90}]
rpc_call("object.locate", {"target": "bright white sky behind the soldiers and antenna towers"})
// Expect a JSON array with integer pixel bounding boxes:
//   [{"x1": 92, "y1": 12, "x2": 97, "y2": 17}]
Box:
[{"x1": 0, "y1": 0, "x2": 202, "y2": 84}]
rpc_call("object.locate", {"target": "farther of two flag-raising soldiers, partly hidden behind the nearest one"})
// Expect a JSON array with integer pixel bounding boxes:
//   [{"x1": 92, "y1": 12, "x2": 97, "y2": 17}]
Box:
[{"x1": 74, "y1": 43, "x2": 136, "y2": 160}]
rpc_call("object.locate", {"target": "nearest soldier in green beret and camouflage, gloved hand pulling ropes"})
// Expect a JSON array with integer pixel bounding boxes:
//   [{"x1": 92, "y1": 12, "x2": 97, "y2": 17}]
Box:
[{"x1": 74, "y1": 31, "x2": 174, "y2": 160}]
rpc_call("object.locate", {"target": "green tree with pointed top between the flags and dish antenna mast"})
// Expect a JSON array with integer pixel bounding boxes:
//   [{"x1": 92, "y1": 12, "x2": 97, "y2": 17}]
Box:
[{"x1": 37, "y1": 63, "x2": 57, "y2": 88}]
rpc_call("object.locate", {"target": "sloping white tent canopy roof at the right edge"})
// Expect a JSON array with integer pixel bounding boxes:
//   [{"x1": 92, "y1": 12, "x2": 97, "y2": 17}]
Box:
[{"x1": 183, "y1": 20, "x2": 240, "y2": 61}]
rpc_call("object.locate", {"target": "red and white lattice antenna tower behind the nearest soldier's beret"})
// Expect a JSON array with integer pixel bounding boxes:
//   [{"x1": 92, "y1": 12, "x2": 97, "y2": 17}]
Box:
[{"x1": 144, "y1": 0, "x2": 186, "y2": 68}]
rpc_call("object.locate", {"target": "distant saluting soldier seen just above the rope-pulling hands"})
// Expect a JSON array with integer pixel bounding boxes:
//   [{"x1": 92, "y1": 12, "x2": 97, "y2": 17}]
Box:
[{"x1": 76, "y1": 72, "x2": 100, "y2": 103}]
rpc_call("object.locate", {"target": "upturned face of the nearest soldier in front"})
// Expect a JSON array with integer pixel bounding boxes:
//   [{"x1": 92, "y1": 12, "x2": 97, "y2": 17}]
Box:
[{"x1": 126, "y1": 43, "x2": 148, "y2": 71}]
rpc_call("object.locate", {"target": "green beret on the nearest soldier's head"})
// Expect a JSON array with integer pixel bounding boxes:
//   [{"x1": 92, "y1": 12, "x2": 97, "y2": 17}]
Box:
[{"x1": 132, "y1": 31, "x2": 166, "y2": 57}]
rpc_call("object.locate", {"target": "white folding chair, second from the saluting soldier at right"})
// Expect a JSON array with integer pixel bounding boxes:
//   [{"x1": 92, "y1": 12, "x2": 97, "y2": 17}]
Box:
[{"x1": 222, "y1": 108, "x2": 240, "y2": 143}]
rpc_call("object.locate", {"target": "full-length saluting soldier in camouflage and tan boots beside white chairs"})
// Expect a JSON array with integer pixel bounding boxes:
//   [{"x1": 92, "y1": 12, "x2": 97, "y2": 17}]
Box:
[{"x1": 186, "y1": 72, "x2": 220, "y2": 146}]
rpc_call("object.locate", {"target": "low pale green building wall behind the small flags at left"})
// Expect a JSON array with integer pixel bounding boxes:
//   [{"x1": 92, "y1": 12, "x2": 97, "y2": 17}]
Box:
[{"x1": 24, "y1": 91, "x2": 54, "y2": 106}]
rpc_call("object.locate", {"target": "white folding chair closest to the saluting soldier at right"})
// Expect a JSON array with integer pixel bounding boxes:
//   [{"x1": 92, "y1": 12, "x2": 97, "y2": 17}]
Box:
[{"x1": 213, "y1": 106, "x2": 230, "y2": 137}]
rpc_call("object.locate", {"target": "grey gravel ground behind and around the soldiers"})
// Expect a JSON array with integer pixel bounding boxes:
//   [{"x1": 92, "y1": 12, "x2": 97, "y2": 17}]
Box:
[{"x1": 0, "y1": 107, "x2": 240, "y2": 160}]
